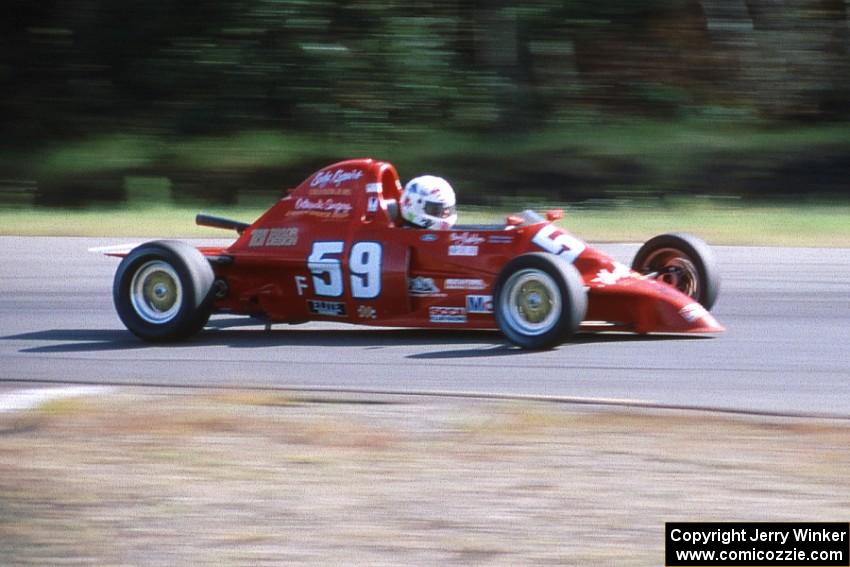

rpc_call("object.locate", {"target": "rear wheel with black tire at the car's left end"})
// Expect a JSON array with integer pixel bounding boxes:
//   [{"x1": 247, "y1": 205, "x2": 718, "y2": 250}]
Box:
[{"x1": 112, "y1": 240, "x2": 215, "y2": 342}]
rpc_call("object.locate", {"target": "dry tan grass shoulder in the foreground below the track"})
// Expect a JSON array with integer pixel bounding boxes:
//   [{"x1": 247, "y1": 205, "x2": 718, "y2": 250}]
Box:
[{"x1": 0, "y1": 389, "x2": 850, "y2": 566}]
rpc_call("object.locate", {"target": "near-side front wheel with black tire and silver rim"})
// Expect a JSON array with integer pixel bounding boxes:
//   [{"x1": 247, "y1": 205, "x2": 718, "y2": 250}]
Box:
[{"x1": 493, "y1": 252, "x2": 587, "y2": 350}]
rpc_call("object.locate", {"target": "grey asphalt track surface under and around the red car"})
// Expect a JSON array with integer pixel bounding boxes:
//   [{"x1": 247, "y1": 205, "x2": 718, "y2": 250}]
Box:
[{"x1": 0, "y1": 237, "x2": 850, "y2": 417}]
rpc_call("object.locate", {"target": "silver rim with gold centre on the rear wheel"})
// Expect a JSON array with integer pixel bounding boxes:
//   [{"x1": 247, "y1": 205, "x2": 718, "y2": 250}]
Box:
[{"x1": 130, "y1": 260, "x2": 183, "y2": 325}]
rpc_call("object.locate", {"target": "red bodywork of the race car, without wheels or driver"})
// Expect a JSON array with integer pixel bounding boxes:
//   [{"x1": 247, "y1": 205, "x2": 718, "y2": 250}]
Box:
[{"x1": 174, "y1": 159, "x2": 723, "y2": 333}]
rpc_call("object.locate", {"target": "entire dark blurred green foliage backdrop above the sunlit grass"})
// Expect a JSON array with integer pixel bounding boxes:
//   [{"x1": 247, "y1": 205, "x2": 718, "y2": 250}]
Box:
[{"x1": 0, "y1": 0, "x2": 850, "y2": 206}]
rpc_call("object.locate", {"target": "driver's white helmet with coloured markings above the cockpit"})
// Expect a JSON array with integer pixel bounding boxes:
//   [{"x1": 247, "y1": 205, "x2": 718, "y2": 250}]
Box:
[{"x1": 401, "y1": 175, "x2": 457, "y2": 230}]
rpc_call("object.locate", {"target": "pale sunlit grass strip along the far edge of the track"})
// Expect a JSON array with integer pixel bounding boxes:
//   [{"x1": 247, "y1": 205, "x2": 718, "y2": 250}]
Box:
[{"x1": 0, "y1": 199, "x2": 850, "y2": 247}]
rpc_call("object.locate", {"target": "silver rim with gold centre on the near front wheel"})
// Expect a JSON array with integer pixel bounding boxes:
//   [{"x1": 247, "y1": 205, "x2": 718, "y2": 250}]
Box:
[{"x1": 500, "y1": 269, "x2": 562, "y2": 336}]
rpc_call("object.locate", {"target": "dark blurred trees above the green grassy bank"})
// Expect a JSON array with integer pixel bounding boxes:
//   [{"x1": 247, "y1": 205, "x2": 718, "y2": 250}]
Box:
[{"x1": 0, "y1": 0, "x2": 850, "y2": 204}]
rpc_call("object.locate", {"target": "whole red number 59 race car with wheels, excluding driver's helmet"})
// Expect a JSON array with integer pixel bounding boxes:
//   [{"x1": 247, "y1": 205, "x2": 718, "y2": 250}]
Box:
[{"x1": 102, "y1": 159, "x2": 724, "y2": 349}]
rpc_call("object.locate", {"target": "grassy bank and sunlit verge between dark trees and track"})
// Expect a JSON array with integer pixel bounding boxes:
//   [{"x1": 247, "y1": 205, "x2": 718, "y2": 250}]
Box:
[{"x1": 0, "y1": 116, "x2": 850, "y2": 246}]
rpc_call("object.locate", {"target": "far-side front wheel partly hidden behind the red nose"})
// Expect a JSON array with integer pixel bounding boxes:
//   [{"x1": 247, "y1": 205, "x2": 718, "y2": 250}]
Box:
[{"x1": 632, "y1": 232, "x2": 720, "y2": 310}]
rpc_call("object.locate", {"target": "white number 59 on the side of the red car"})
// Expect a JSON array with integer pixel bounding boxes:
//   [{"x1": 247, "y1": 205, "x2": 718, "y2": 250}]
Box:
[{"x1": 307, "y1": 240, "x2": 383, "y2": 299}]
